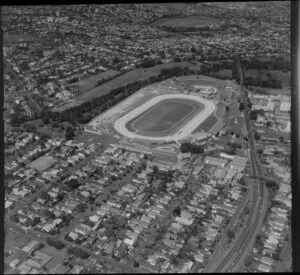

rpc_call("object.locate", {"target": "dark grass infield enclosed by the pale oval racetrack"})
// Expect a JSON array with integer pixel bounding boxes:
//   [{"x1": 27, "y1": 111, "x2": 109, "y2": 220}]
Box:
[{"x1": 126, "y1": 99, "x2": 204, "y2": 136}]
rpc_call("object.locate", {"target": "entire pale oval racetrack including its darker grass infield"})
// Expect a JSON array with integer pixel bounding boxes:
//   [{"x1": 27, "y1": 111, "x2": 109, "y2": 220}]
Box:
[{"x1": 114, "y1": 94, "x2": 215, "y2": 141}]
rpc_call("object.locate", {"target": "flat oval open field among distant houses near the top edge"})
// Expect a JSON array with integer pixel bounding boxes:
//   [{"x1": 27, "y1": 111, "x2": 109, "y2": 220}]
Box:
[{"x1": 153, "y1": 15, "x2": 220, "y2": 28}]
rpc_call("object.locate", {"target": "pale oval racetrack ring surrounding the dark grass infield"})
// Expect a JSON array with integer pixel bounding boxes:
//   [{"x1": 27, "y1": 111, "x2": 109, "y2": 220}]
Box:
[{"x1": 114, "y1": 94, "x2": 215, "y2": 141}]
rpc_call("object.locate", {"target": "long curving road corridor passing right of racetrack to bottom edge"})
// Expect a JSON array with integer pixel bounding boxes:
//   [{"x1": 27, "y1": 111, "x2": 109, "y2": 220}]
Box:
[{"x1": 209, "y1": 56, "x2": 267, "y2": 273}]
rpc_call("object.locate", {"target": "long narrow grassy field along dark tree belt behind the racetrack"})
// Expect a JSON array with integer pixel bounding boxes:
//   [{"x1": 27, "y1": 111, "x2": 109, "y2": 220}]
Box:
[{"x1": 75, "y1": 61, "x2": 195, "y2": 102}]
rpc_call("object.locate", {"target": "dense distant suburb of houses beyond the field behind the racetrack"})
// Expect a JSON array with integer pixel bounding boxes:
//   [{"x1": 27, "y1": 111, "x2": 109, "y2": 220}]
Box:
[{"x1": 4, "y1": 1, "x2": 289, "y2": 116}]
